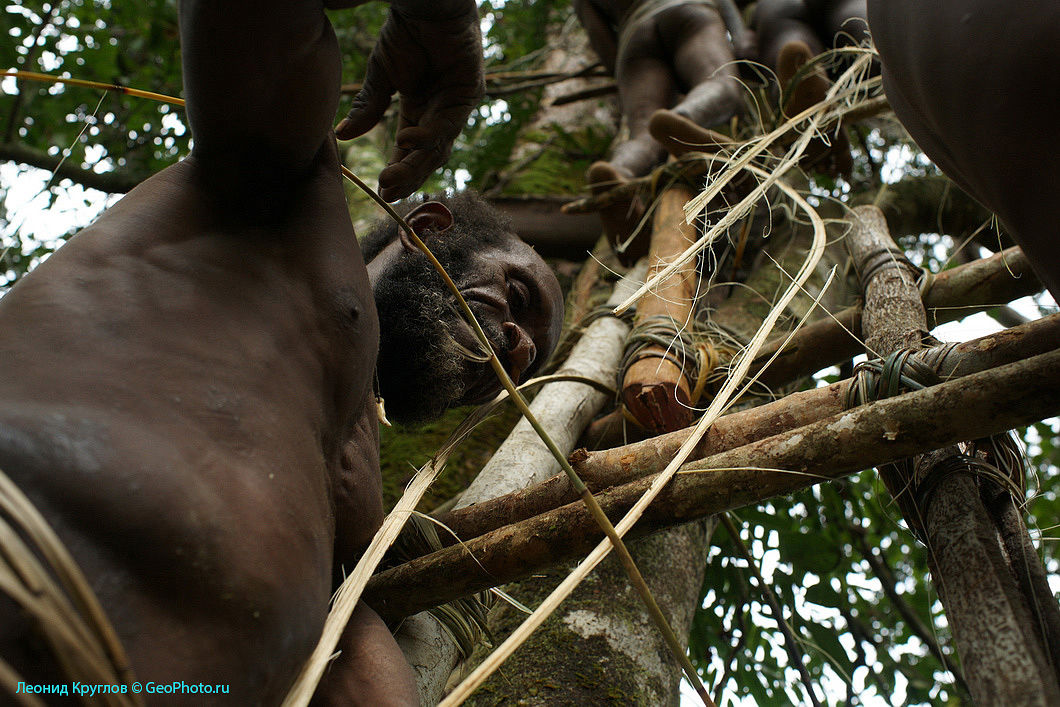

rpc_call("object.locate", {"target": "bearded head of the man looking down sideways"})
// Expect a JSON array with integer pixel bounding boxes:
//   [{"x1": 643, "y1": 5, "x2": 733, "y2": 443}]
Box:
[{"x1": 368, "y1": 195, "x2": 563, "y2": 424}]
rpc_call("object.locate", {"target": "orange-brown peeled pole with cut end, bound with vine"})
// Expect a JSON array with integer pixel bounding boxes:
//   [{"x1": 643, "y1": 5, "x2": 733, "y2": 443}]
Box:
[{"x1": 622, "y1": 185, "x2": 696, "y2": 435}]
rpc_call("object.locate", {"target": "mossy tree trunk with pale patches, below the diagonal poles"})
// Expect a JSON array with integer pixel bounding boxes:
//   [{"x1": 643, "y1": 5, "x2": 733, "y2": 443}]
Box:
[{"x1": 465, "y1": 518, "x2": 714, "y2": 706}]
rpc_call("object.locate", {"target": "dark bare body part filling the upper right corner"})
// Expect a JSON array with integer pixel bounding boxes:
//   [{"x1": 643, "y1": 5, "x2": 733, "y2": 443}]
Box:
[{"x1": 868, "y1": 0, "x2": 1060, "y2": 300}]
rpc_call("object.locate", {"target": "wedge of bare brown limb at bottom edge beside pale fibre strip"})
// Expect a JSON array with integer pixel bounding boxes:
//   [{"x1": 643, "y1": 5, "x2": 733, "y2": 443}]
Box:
[{"x1": 313, "y1": 603, "x2": 420, "y2": 707}]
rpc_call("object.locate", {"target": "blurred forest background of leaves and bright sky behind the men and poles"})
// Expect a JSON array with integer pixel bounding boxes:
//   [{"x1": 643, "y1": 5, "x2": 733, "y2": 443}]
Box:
[{"x1": 0, "y1": 0, "x2": 1060, "y2": 705}]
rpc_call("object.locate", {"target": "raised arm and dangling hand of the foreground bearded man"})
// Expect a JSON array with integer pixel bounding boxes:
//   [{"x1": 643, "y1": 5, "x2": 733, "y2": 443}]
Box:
[{"x1": 180, "y1": 0, "x2": 483, "y2": 199}]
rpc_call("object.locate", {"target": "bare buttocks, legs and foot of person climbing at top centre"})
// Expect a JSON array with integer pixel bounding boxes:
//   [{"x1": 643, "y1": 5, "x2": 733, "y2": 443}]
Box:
[{"x1": 575, "y1": 0, "x2": 742, "y2": 261}]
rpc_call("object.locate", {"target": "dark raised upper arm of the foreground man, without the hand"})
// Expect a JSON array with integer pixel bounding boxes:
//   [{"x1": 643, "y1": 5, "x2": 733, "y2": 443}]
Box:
[{"x1": 180, "y1": 0, "x2": 340, "y2": 179}]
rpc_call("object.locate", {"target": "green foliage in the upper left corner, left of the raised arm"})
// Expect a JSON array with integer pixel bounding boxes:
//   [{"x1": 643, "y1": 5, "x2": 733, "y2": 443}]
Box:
[{"x1": 0, "y1": 0, "x2": 190, "y2": 178}]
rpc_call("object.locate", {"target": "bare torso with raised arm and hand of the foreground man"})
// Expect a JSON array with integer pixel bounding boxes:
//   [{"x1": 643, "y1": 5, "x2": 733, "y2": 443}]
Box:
[{"x1": 0, "y1": 0, "x2": 562, "y2": 705}]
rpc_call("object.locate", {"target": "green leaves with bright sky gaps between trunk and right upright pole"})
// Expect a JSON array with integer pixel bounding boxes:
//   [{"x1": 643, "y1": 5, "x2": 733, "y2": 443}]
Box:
[{"x1": 690, "y1": 473, "x2": 955, "y2": 704}]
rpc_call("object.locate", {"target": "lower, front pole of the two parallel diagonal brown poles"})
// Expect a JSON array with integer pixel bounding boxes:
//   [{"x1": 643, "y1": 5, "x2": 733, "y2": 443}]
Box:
[{"x1": 365, "y1": 351, "x2": 1060, "y2": 619}]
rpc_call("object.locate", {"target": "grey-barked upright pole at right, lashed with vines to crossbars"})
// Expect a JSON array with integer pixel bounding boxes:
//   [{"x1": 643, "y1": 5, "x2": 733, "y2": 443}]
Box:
[{"x1": 846, "y1": 201, "x2": 1060, "y2": 707}]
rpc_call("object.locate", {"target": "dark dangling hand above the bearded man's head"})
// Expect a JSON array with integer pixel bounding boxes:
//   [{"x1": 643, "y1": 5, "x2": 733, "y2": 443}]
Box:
[{"x1": 335, "y1": 2, "x2": 485, "y2": 201}]
